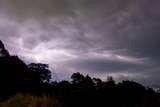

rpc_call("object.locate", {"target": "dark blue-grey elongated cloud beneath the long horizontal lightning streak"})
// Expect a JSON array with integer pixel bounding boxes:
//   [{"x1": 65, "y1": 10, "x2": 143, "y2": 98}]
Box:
[{"x1": 71, "y1": 55, "x2": 147, "y2": 73}]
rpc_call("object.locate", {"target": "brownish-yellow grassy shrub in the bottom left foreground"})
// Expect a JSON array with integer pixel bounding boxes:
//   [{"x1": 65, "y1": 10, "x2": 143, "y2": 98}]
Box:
[{"x1": 0, "y1": 94, "x2": 63, "y2": 107}]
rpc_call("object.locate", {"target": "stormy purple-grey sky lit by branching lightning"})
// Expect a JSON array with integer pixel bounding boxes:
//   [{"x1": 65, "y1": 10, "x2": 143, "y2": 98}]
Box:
[{"x1": 0, "y1": 0, "x2": 160, "y2": 88}]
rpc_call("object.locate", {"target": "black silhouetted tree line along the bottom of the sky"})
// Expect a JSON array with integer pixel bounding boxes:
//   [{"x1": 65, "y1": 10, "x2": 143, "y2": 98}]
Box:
[{"x1": 0, "y1": 41, "x2": 160, "y2": 107}]
